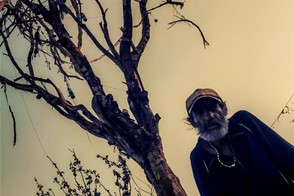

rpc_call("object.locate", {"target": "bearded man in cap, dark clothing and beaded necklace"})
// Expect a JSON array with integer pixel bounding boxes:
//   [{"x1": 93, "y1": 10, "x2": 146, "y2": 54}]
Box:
[{"x1": 186, "y1": 88, "x2": 294, "y2": 196}]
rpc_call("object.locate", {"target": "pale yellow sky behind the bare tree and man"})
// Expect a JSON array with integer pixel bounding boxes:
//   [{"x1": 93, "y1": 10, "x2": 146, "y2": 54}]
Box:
[{"x1": 0, "y1": 0, "x2": 294, "y2": 196}]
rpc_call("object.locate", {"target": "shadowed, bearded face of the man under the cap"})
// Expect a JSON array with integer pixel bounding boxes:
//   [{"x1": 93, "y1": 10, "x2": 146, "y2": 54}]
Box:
[{"x1": 192, "y1": 98, "x2": 228, "y2": 141}]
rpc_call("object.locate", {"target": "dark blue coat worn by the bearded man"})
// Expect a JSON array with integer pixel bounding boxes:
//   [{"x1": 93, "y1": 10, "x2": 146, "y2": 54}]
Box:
[{"x1": 190, "y1": 111, "x2": 294, "y2": 196}]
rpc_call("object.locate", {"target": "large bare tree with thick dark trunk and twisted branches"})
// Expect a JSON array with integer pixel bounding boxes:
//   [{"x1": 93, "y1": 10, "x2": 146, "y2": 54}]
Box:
[{"x1": 0, "y1": 0, "x2": 208, "y2": 196}]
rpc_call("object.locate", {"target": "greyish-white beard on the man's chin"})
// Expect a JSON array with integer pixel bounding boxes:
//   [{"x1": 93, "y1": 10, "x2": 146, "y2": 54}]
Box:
[{"x1": 199, "y1": 119, "x2": 229, "y2": 142}]
